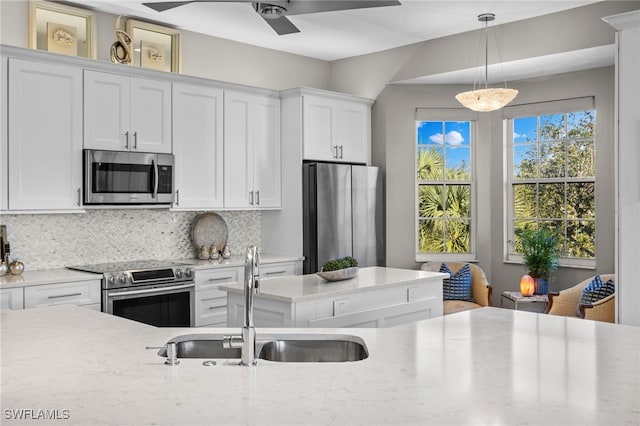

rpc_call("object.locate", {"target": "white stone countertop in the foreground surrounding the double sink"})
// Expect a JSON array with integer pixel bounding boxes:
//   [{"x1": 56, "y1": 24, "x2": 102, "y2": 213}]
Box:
[{"x1": 0, "y1": 305, "x2": 640, "y2": 426}]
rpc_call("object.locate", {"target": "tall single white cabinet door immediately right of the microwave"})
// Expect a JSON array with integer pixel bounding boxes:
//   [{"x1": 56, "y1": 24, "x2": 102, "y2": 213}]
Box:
[{"x1": 173, "y1": 83, "x2": 224, "y2": 209}]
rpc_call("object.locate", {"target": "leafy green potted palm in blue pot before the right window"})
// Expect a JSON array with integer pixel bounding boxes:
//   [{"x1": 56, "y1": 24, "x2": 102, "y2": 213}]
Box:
[{"x1": 519, "y1": 228, "x2": 559, "y2": 294}]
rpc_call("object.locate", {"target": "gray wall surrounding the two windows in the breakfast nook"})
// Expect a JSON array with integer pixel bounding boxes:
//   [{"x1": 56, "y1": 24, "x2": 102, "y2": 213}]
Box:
[{"x1": 373, "y1": 67, "x2": 614, "y2": 303}]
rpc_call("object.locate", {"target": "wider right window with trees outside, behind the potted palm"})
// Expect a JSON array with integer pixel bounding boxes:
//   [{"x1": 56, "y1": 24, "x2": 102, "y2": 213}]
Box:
[{"x1": 506, "y1": 98, "x2": 596, "y2": 266}]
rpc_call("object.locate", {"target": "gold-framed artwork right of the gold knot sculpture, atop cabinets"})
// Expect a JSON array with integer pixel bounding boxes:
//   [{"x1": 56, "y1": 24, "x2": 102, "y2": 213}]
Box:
[{"x1": 127, "y1": 19, "x2": 180, "y2": 73}]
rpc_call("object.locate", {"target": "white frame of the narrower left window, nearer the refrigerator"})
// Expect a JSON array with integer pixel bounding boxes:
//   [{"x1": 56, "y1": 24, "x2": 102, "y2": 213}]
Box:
[{"x1": 412, "y1": 109, "x2": 478, "y2": 262}]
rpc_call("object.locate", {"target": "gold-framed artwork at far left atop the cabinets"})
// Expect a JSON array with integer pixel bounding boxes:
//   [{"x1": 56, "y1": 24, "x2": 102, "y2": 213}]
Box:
[{"x1": 29, "y1": 1, "x2": 96, "y2": 59}]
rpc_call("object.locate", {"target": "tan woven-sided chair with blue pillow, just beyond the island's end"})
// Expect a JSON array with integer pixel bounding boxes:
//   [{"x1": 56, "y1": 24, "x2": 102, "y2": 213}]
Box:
[{"x1": 420, "y1": 262, "x2": 493, "y2": 315}]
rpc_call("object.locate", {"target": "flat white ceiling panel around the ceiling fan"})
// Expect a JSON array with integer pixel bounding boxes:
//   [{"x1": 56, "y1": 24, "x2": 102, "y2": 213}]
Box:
[{"x1": 73, "y1": 0, "x2": 596, "y2": 61}]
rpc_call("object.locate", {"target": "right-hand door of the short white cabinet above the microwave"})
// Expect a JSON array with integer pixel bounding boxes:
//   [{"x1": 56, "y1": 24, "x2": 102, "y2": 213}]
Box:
[{"x1": 129, "y1": 77, "x2": 172, "y2": 154}]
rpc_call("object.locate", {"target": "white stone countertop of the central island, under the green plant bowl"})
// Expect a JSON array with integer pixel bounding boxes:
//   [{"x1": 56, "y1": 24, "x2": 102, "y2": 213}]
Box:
[{"x1": 220, "y1": 266, "x2": 449, "y2": 303}]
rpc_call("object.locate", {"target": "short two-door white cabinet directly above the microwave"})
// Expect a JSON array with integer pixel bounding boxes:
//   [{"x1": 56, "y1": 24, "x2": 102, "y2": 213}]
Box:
[{"x1": 84, "y1": 70, "x2": 172, "y2": 154}]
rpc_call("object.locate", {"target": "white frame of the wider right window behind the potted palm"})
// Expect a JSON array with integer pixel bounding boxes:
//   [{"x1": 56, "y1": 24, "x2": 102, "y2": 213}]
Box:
[{"x1": 503, "y1": 97, "x2": 598, "y2": 269}]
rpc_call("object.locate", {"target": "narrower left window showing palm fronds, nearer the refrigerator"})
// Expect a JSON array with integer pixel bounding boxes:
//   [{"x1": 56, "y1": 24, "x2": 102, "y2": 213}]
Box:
[{"x1": 416, "y1": 114, "x2": 475, "y2": 261}]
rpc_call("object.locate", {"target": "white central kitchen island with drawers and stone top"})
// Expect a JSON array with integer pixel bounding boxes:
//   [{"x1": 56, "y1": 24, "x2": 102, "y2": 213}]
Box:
[{"x1": 220, "y1": 266, "x2": 448, "y2": 327}]
